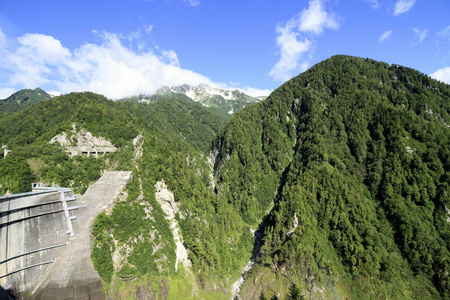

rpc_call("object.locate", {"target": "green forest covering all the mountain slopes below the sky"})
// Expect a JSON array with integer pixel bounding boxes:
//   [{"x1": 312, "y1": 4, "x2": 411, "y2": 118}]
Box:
[{"x1": 0, "y1": 56, "x2": 450, "y2": 299}]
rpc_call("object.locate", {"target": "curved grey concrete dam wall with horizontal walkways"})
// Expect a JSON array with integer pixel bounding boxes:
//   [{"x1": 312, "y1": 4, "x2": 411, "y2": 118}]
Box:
[{"x1": 0, "y1": 188, "x2": 75, "y2": 292}]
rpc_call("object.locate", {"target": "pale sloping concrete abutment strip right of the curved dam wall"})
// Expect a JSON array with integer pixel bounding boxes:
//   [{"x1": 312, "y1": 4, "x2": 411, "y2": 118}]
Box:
[{"x1": 32, "y1": 172, "x2": 131, "y2": 299}]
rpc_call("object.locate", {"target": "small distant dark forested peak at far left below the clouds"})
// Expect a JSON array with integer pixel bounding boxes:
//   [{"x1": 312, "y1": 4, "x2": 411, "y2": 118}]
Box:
[{"x1": 0, "y1": 88, "x2": 52, "y2": 116}]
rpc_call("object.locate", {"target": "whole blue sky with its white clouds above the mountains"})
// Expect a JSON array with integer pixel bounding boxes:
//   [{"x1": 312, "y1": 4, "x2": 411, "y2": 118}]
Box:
[{"x1": 0, "y1": 0, "x2": 450, "y2": 99}]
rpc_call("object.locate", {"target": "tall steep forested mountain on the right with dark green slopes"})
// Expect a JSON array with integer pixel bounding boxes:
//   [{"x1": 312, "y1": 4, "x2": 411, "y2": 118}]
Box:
[{"x1": 213, "y1": 56, "x2": 450, "y2": 299}]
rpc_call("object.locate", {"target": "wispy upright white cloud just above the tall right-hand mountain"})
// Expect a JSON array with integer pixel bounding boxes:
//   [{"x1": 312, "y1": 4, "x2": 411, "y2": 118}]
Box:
[{"x1": 269, "y1": 0, "x2": 339, "y2": 81}]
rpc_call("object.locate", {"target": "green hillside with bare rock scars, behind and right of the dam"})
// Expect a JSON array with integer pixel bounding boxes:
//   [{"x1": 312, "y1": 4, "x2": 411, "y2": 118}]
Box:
[{"x1": 0, "y1": 93, "x2": 252, "y2": 299}]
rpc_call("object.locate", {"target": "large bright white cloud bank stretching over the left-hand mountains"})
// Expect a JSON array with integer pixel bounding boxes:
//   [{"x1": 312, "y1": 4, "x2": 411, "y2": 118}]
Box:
[{"x1": 0, "y1": 33, "x2": 268, "y2": 99}]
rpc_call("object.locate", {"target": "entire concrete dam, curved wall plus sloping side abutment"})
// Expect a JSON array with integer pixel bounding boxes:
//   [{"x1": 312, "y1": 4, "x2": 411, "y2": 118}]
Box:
[{"x1": 0, "y1": 172, "x2": 131, "y2": 299}]
